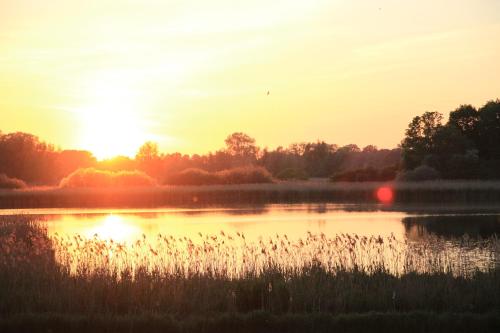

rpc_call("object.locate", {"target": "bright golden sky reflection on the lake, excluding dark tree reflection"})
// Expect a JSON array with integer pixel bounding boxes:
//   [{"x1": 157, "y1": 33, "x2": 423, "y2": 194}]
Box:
[{"x1": 39, "y1": 205, "x2": 405, "y2": 242}]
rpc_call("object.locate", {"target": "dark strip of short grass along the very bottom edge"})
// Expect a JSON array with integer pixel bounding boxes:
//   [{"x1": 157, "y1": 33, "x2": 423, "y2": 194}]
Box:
[{"x1": 0, "y1": 311, "x2": 500, "y2": 333}]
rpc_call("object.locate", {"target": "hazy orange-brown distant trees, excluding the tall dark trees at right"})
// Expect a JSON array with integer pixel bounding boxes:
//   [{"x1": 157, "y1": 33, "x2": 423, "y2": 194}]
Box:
[{"x1": 0, "y1": 132, "x2": 401, "y2": 185}]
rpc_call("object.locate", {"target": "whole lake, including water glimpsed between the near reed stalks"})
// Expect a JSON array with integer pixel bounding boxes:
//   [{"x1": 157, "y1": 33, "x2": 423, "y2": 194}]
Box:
[{"x1": 1, "y1": 204, "x2": 500, "y2": 272}]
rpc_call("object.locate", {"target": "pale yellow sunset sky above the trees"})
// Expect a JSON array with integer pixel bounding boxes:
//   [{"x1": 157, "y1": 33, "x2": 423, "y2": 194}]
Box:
[{"x1": 0, "y1": 0, "x2": 500, "y2": 158}]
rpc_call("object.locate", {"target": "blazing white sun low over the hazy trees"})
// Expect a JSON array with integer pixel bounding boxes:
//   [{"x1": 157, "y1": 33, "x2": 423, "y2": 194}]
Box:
[{"x1": 76, "y1": 71, "x2": 148, "y2": 160}]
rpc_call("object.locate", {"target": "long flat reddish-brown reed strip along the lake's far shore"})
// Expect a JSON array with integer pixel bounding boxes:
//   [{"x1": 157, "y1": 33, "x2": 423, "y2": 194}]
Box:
[{"x1": 0, "y1": 181, "x2": 500, "y2": 209}]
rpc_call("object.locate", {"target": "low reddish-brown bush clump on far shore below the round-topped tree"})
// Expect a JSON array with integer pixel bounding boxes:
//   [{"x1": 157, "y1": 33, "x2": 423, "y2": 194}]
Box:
[{"x1": 164, "y1": 166, "x2": 273, "y2": 185}]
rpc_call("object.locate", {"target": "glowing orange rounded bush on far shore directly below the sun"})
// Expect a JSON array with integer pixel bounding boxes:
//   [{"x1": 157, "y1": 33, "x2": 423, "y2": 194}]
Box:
[{"x1": 59, "y1": 168, "x2": 156, "y2": 188}]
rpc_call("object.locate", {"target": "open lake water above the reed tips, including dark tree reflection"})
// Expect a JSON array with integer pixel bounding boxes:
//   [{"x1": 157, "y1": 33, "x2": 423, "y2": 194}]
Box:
[{"x1": 1, "y1": 204, "x2": 500, "y2": 242}]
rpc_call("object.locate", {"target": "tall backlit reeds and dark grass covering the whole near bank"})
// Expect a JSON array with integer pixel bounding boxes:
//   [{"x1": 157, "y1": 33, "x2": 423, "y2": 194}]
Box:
[{"x1": 0, "y1": 216, "x2": 500, "y2": 332}]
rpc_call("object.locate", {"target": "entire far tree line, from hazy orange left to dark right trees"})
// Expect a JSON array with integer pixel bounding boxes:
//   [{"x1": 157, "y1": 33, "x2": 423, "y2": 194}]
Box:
[{"x1": 0, "y1": 100, "x2": 500, "y2": 185}]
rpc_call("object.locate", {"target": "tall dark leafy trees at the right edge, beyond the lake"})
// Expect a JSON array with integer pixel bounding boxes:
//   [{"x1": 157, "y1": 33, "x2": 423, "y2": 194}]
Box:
[{"x1": 401, "y1": 100, "x2": 500, "y2": 179}]
